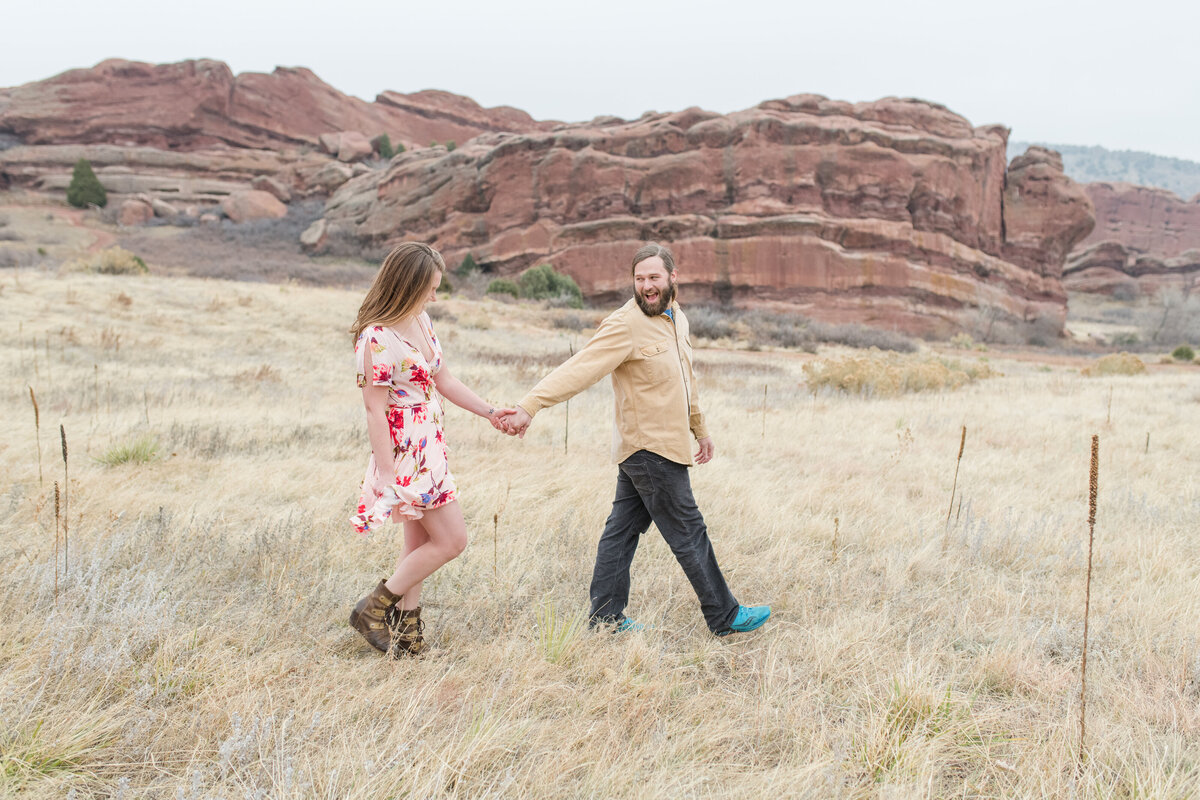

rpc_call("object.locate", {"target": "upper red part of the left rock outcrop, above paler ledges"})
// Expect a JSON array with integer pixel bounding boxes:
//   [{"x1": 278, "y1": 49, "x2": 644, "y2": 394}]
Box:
[{"x1": 0, "y1": 59, "x2": 552, "y2": 150}]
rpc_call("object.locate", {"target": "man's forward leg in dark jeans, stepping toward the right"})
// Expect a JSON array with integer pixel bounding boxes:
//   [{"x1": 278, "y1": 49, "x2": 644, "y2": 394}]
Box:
[{"x1": 622, "y1": 450, "x2": 738, "y2": 633}]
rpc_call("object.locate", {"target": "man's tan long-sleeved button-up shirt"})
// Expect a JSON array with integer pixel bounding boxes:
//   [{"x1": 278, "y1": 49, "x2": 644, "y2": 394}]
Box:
[{"x1": 518, "y1": 300, "x2": 708, "y2": 465}]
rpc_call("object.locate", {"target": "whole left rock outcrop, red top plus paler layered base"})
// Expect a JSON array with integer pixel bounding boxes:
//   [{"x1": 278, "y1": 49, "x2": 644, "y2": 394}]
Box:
[{"x1": 0, "y1": 59, "x2": 554, "y2": 219}]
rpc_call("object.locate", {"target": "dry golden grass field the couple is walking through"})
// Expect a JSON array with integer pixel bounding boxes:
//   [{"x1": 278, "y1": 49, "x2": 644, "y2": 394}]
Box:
[{"x1": 0, "y1": 270, "x2": 1200, "y2": 800}]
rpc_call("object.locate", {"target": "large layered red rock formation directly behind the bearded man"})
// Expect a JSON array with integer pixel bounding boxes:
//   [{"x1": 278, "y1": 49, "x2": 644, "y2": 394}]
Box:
[{"x1": 308, "y1": 95, "x2": 1092, "y2": 332}]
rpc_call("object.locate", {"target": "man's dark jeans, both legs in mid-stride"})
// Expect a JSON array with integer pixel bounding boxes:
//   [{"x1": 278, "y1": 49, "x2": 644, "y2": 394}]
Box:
[{"x1": 590, "y1": 450, "x2": 738, "y2": 632}]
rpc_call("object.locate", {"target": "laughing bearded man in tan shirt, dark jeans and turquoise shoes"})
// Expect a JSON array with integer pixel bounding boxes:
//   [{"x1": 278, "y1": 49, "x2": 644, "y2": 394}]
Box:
[{"x1": 505, "y1": 243, "x2": 770, "y2": 636}]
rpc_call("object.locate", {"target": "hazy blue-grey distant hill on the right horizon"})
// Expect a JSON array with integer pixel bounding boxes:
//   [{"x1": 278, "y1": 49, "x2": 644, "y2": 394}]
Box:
[{"x1": 1008, "y1": 142, "x2": 1200, "y2": 200}]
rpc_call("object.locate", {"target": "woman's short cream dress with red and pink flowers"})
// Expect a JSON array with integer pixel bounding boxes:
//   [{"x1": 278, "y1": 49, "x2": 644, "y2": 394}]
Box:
[{"x1": 350, "y1": 313, "x2": 457, "y2": 534}]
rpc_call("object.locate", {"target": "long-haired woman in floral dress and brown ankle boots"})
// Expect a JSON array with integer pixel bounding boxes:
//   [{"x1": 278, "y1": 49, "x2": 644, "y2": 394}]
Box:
[{"x1": 350, "y1": 242, "x2": 511, "y2": 657}]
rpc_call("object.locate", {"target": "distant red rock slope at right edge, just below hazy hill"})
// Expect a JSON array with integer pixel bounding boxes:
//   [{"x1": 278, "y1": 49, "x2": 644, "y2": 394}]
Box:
[{"x1": 1080, "y1": 184, "x2": 1200, "y2": 259}]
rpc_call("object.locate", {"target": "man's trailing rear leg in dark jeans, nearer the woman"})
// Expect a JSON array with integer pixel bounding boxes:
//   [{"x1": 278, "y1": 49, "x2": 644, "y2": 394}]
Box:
[{"x1": 589, "y1": 464, "x2": 650, "y2": 625}]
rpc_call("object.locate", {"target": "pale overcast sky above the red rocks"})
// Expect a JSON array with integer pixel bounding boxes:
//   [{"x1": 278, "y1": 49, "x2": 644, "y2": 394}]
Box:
[{"x1": 9, "y1": 0, "x2": 1200, "y2": 161}]
